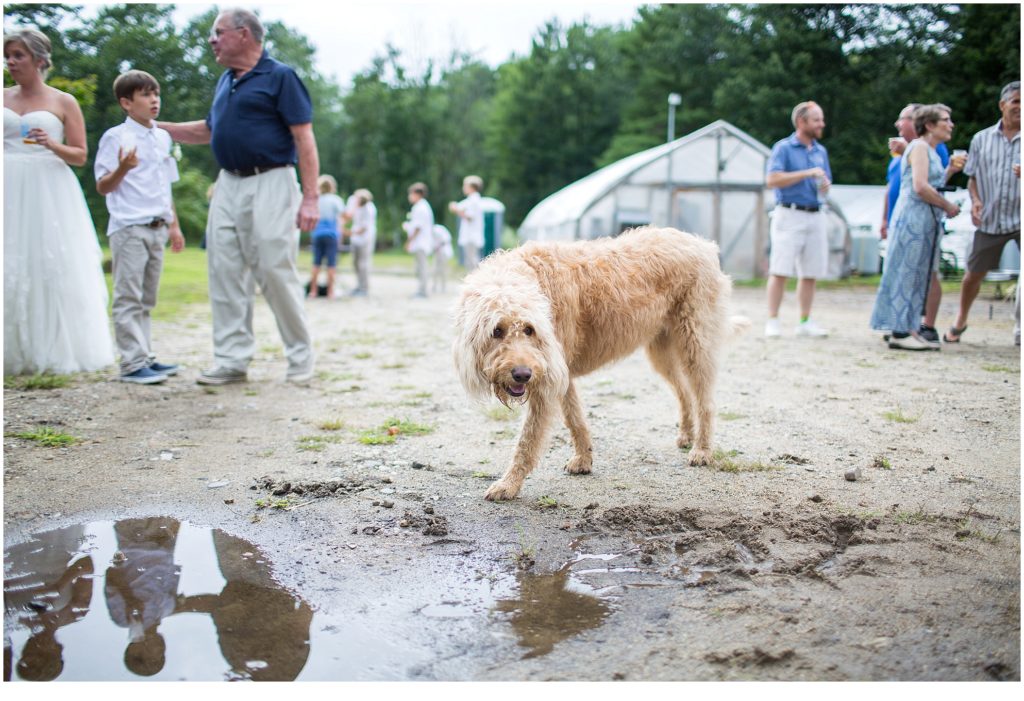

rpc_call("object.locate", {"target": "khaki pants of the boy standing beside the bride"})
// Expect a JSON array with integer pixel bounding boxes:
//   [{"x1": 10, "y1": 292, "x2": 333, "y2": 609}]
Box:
[{"x1": 110, "y1": 225, "x2": 167, "y2": 375}]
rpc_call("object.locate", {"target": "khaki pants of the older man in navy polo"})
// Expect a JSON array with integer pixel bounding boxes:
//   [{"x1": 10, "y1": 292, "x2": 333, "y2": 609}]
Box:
[{"x1": 206, "y1": 168, "x2": 313, "y2": 376}]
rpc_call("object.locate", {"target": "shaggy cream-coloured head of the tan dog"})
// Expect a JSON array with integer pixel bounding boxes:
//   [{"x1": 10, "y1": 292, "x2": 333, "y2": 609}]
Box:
[{"x1": 453, "y1": 274, "x2": 568, "y2": 406}]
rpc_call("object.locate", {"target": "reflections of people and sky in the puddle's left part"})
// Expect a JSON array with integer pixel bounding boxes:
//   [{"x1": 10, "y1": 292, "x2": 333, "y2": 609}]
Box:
[{"x1": 4, "y1": 518, "x2": 312, "y2": 681}]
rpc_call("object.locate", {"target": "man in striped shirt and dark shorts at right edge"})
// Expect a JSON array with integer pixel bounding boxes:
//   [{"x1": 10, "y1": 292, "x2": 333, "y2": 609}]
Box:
[{"x1": 943, "y1": 81, "x2": 1021, "y2": 346}]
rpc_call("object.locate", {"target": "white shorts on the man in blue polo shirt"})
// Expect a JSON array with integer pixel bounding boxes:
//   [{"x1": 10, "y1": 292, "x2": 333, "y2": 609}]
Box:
[{"x1": 768, "y1": 206, "x2": 828, "y2": 279}]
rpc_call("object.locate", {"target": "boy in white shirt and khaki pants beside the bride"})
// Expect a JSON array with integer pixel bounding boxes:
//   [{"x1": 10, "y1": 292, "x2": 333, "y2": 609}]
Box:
[{"x1": 94, "y1": 71, "x2": 185, "y2": 385}]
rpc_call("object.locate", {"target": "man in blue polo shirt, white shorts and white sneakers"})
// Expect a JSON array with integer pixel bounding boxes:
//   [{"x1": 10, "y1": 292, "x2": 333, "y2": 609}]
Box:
[{"x1": 765, "y1": 101, "x2": 831, "y2": 338}]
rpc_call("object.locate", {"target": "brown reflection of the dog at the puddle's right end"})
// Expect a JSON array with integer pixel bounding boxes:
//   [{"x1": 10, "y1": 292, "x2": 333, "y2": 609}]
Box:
[{"x1": 495, "y1": 563, "x2": 611, "y2": 659}]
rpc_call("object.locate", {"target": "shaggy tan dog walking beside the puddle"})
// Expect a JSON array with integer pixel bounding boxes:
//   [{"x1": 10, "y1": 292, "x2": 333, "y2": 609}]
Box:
[{"x1": 452, "y1": 227, "x2": 750, "y2": 500}]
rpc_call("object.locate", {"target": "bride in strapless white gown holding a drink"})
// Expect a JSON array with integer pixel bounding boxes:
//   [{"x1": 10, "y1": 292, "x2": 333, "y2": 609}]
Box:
[{"x1": 3, "y1": 29, "x2": 114, "y2": 375}]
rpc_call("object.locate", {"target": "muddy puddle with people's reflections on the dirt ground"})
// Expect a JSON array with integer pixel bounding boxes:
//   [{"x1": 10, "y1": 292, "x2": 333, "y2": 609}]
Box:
[{"x1": 4, "y1": 517, "x2": 629, "y2": 681}]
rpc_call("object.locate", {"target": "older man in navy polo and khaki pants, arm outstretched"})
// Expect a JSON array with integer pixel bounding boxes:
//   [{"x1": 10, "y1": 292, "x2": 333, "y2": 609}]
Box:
[{"x1": 159, "y1": 9, "x2": 319, "y2": 385}]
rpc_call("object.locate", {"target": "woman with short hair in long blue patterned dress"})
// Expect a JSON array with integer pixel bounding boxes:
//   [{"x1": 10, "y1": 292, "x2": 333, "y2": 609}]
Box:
[{"x1": 871, "y1": 104, "x2": 959, "y2": 350}]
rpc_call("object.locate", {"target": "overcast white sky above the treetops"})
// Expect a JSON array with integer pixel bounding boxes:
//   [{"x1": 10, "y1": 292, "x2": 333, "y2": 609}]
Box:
[{"x1": 175, "y1": 0, "x2": 643, "y2": 86}]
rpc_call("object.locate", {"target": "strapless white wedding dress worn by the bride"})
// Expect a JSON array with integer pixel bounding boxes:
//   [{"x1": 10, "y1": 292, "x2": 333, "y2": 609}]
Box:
[{"x1": 3, "y1": 107, "x2": 114, "y2": 375}]
